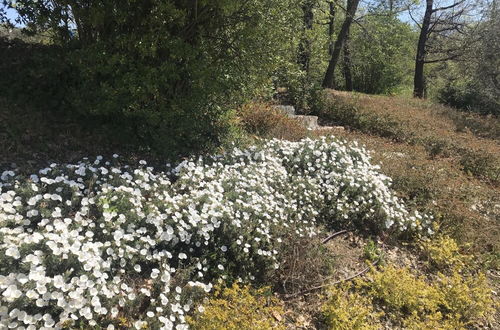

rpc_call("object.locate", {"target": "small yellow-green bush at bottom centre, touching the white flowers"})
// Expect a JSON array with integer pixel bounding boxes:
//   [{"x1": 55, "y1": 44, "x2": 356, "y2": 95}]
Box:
[{"x1": 187, "y1": 284, "x2": 285, "y2": 330}]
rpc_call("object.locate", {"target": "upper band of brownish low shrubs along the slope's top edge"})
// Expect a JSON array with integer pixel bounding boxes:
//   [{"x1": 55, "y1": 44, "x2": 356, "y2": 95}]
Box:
[{"x1": 316, "y1": 92, "x2": 500, "y2": 185}]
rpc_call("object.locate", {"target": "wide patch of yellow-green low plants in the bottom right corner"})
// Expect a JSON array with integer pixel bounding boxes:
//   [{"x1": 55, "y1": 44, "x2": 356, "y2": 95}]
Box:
[{"x1": 322, "y1": 265, "x2": 494, "y2": 330}]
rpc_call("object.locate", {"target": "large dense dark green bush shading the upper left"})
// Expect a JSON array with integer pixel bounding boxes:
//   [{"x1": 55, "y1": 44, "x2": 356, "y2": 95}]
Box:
[{"x1": 5, "y1": 0, "x2": 296, "y2": 154}]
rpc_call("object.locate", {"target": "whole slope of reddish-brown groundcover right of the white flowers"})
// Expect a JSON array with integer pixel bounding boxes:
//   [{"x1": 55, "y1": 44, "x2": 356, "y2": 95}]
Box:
[{"x1": 319, "y1": 91, "x2": 500, "y2": 260}]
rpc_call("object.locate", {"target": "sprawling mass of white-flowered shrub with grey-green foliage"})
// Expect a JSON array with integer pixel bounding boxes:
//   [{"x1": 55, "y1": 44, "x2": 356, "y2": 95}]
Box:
[{"x1": 0, "y1": 138, "x2": 431, "y2": 329}]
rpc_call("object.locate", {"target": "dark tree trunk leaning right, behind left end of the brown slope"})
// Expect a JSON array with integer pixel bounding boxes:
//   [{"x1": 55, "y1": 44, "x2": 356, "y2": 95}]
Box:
[{"x1": 322, "y1": 0, "x2": 359, "y2": 88}]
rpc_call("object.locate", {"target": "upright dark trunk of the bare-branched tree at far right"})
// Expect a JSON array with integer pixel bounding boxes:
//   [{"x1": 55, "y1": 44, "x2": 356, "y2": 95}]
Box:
[{"x1": 413, "y1": 0, "x2": 434, "y2": 98}]
